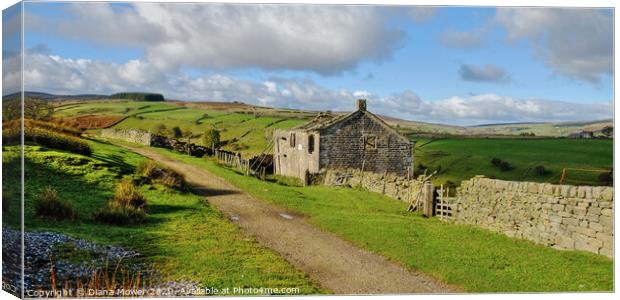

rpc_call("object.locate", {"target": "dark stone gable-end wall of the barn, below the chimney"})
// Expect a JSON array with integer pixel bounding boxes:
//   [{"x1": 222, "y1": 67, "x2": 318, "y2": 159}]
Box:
[{"x1": 319, "y1": 111, "x2": 413, "y2": 176}]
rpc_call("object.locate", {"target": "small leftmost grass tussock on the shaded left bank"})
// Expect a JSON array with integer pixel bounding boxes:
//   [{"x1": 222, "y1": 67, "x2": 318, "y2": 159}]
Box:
[{"x1": 34, "y1": 186, "x2": 77, "y2": 220}]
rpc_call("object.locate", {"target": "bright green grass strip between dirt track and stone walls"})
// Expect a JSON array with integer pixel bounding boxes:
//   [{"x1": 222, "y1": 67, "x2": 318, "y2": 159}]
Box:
[{"x1": 138, "y1": 148, "x2": 613, "y2": 292}]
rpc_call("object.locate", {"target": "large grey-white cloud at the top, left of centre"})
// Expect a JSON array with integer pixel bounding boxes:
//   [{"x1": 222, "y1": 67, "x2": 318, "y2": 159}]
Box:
[{"x1": 32, "y1": 2, "x2": 404, "y2": 75}]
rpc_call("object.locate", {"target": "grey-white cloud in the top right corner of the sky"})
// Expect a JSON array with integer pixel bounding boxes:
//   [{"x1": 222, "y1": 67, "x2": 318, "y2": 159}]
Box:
[{"x1": 496, "y1": 8, "x2": 613, "y2": 83}]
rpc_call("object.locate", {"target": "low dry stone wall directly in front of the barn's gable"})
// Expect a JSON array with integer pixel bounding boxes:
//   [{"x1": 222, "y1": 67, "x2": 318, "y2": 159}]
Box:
[{"x1": 323, "y1": 169, "x2": 423, "y2": 202}]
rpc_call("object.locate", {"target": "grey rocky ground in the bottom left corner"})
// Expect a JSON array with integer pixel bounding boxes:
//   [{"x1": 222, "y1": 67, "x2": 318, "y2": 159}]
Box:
[{"x1": 2, "y1": 228, "x2": 196, "y2": 295}]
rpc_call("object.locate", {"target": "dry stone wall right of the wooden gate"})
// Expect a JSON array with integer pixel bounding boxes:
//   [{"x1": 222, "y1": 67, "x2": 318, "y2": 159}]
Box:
[{"x1": 453, "y1": 176, "x2": 614, "y2": 257}]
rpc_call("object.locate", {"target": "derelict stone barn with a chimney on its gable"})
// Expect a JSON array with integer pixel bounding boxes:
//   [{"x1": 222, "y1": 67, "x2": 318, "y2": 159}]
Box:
[{"x1": 274, "y1": 100, "x2": 413, "y2": 180}]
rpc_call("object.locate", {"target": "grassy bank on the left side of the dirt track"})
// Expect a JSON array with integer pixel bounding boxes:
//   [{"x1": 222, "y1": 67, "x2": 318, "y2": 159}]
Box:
[{"x1": 3, "y1": 141, "x2": 326, "y2": 294}]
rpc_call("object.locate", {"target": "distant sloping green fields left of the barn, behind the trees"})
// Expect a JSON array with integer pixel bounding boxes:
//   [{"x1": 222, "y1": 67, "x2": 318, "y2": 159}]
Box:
[{"x1": 54, "y1": 102, "x2": 307, "y2": 157}]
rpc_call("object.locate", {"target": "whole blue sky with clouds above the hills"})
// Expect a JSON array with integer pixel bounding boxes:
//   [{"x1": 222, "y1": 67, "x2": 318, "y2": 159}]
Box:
[{"x1": 3, "y1": 2, "x2": 613, "y2": 125}]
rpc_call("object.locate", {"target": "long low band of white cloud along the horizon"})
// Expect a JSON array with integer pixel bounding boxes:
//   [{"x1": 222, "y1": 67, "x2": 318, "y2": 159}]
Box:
[{"x1": 9, "y1": 52, "x2": 613, "y2": 125}]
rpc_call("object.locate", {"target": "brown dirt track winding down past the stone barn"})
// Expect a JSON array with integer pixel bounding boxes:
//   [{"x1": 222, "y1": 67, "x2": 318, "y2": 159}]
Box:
[{"x1": 124, "y1": 146, "x2": 459, "y2": 294}]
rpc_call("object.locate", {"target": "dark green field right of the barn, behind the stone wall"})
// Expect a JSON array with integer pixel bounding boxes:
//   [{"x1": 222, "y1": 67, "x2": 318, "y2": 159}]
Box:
[{"x1": 413, "y1": 137, "x2": 613, "y2": 185}]
